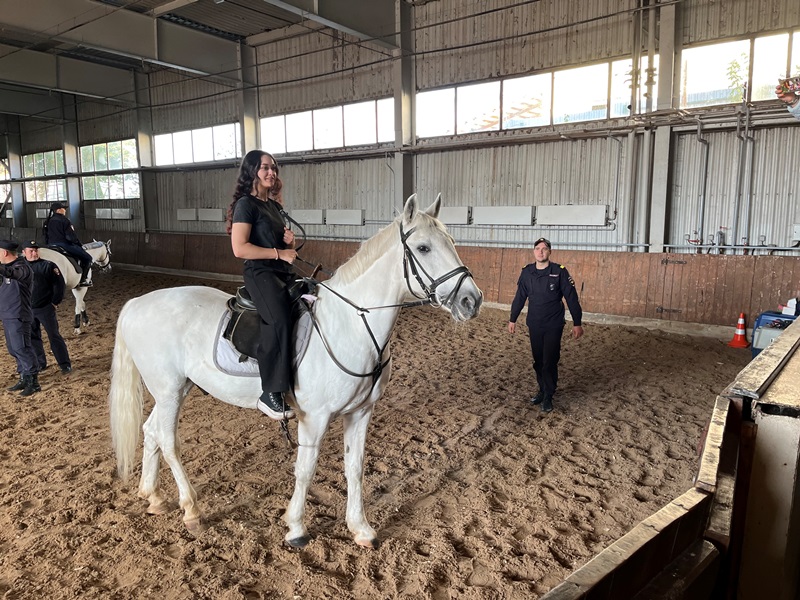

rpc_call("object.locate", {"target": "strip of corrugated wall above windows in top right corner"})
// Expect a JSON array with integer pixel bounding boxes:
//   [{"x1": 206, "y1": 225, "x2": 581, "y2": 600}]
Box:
[{"x1": 681, "y1": 0, "x2": 800, "y2": 45}]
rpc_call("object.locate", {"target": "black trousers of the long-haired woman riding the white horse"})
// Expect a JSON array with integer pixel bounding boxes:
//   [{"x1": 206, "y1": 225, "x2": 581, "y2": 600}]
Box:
[{"x1": 244, "y1": 265, "x2": 294, "y2": 392}]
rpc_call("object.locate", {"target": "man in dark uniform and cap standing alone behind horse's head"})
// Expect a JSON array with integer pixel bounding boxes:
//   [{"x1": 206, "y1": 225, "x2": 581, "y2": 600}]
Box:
[{"x1": 508, "y1": 238, "x2": 583, "y2": 412}]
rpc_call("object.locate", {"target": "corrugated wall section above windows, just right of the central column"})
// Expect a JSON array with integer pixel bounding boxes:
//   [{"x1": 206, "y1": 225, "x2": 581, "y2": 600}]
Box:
[{"x1": 414, "y1": 0, "x2": 637, "y2": 90}]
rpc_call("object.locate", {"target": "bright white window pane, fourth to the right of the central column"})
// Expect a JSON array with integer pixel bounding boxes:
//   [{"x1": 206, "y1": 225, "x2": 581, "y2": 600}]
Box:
[{"x1": 553, "y1": 63, "x2": 610, "y2": 123}]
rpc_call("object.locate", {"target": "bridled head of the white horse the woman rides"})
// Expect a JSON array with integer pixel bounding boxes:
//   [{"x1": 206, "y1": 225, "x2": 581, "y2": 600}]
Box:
[{"x1": 398, "y1": 194, "x2": 483, "y2": 321}]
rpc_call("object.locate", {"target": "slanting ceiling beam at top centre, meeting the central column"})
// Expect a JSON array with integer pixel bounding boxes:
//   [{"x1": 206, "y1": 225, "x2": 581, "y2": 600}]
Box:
[{"x1": 264, "y1": 0, "x2": 397, "y2": 50}]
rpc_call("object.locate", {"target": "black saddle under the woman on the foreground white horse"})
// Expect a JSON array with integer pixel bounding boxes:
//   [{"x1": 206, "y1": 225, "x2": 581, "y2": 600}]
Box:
[{"x1": 222, "y1": 279, "x2": 313, "y2": 362}]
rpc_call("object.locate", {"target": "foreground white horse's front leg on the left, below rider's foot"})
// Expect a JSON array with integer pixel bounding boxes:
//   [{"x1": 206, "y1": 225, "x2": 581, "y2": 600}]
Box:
[{"x1": 283, "y1": 413, "x2": 330, "y2": 548}]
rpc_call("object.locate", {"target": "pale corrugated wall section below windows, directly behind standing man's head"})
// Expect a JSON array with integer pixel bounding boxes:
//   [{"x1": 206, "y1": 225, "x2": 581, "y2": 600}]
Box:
[{"x1": 417, "y1": 137, "x2": 637, "y2": 249}]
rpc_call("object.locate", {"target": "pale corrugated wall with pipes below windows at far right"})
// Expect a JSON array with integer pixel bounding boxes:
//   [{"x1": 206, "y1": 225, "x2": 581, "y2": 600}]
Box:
[{"x1": 669, "y1": 127, "x2": 800, "y2": 252}]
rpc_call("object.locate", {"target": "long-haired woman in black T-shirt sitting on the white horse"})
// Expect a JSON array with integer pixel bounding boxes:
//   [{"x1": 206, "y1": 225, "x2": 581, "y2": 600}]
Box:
[{"x1": 227, "y1": 150, "x2": 297, "y2": 420}]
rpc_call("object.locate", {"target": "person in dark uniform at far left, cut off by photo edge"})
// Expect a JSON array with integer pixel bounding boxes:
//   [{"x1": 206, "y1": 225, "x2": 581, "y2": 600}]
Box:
[{"x1": 0, "y1": 240, "x2": 42, "y2": 396}]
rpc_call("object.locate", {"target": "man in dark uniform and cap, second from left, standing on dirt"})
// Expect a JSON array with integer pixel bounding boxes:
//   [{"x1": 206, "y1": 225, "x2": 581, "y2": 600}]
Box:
[{"x1": 22, "y1": 241, "x2": 72, "y2": 373}]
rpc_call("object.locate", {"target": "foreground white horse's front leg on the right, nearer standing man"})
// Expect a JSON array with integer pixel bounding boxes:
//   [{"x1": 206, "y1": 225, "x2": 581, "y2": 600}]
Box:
[{"x1": 344, "y1": 404, "x2": 378, "y2": 549}]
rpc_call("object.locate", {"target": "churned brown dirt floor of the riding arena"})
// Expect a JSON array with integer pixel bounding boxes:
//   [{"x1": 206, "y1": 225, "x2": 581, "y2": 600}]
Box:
[{"x1": 0, "y1": 270, "x2": 750, "y2": 600}]
